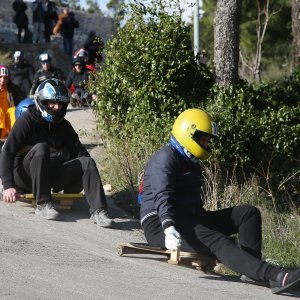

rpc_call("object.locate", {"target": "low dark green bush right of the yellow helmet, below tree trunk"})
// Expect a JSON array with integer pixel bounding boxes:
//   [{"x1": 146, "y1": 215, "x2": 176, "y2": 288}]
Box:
[{"x1": 205, "y1": 72, "x2": 300, "y2": 208}]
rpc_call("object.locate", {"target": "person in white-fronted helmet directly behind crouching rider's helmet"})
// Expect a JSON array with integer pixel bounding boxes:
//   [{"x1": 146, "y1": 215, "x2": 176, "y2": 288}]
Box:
[{"x1": 30, "y1": 52, "x2": 64, "y2": 95}]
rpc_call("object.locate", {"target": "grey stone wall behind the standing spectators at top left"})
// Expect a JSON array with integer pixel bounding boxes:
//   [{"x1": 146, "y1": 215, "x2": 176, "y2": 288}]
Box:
[{"x1": 0, "y1": 0, "x2": 115, "y2": 50}]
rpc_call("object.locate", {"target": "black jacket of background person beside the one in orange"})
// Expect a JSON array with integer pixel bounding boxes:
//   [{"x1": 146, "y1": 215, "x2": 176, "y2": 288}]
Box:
[{"x1": 9, "y1": 63, "x2": 34, "y2": 96}]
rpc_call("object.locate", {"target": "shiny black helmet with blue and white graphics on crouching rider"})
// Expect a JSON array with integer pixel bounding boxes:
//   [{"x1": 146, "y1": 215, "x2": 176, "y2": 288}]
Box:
[{"x1": 34, "y1": 79, "x2": 70, "y2": 123}]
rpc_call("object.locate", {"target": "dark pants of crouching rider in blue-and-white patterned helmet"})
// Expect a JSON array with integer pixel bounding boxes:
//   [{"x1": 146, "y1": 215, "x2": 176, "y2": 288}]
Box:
[{"x1": 14, "y1": 143, "x2": 107, "y2": 214}]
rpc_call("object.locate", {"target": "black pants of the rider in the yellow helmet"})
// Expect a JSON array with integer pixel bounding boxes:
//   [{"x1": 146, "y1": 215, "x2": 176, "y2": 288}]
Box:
[{"x1": 142, "y1": 205, "x2": 280, "y2": 281}]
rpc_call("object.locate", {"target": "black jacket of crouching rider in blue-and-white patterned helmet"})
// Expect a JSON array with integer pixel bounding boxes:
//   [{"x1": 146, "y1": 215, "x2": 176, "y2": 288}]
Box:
[{"x1": 0, "y1": 106, "x2": 90, "y2": 189}]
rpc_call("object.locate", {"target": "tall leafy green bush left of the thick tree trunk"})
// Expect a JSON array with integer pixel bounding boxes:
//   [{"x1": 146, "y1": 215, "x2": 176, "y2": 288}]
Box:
[{"x1": 89, "y1": 4, "x2": 214, "y2": 199}]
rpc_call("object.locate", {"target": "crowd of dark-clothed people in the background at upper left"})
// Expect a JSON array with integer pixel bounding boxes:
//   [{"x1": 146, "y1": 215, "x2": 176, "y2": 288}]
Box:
[{"x1": 7, "y1": 0, "x2": 104, "y2": 106}]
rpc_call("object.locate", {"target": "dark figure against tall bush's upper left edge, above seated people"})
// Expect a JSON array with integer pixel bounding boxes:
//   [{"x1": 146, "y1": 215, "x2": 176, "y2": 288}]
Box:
[{"x1": 84, "y1": 30, "x2": 104, "y2": 65}]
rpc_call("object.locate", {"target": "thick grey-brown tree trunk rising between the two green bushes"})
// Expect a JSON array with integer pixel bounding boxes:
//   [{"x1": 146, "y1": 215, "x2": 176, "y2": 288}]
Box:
[{"x1": 214, "y1": 0, "x2": 242, "y2": 86}]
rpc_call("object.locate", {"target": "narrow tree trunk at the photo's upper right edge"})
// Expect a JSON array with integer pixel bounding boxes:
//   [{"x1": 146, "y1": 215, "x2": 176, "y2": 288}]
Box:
[{"x1": 292, "y1": 0, "x2": 300, "y2": 68}]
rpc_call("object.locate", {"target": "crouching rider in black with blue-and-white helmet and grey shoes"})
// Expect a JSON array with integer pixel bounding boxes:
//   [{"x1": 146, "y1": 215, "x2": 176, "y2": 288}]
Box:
[{"x1": 0, "y1": 79, "x2": 113, "y2": 227}]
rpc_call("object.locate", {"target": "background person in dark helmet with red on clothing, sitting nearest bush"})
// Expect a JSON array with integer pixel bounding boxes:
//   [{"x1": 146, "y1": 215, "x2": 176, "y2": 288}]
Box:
[{"x1": 66, "y1": 57, "x2": 90, "y2": 107}]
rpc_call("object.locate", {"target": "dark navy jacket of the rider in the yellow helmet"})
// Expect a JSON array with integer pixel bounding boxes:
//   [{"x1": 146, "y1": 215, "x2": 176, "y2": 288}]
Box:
[{"x1": 140, "y1": 145, "x2": 203, "y2": 229}]
